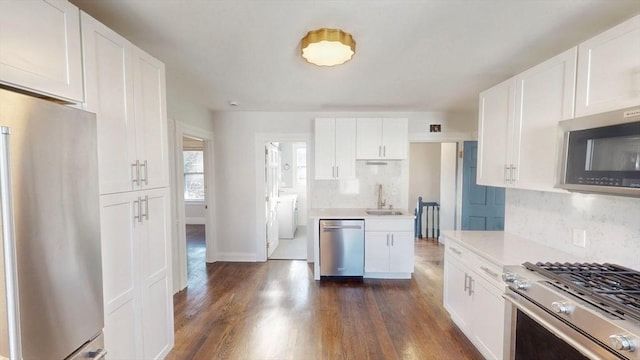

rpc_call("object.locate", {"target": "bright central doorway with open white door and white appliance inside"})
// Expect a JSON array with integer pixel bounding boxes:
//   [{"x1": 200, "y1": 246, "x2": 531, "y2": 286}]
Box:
[{"x1": 264, "y1": 142, "x2": 308, "y2": 260}]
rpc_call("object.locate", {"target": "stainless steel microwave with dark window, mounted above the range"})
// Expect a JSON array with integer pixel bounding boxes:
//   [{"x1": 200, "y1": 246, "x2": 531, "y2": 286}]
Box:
[{"x1": 556, "y1": 107, "x2": 640, "y2": 197}]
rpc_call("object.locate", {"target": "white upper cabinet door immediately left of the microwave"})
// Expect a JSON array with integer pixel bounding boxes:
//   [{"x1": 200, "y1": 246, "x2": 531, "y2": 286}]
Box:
[{"x1": 511, "y1": 48, "x2": 577, "y2": 190}]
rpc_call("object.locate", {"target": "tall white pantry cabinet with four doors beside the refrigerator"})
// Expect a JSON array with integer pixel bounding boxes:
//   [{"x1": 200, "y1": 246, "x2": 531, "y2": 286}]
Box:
[{"x1": 81, "y1": 13, "x2": 174, "y2": 359}]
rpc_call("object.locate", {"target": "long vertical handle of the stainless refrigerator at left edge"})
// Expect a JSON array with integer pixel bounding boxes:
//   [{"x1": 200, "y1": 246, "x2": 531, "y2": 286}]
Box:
[{"x1": 0, "y1": 126, "x2": 22, "y2": 359}]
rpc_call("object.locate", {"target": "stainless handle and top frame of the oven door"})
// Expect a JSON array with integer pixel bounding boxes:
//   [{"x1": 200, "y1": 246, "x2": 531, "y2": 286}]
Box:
[{"x1": 502, "y1": 287, "x2": 602, "y2": 359}]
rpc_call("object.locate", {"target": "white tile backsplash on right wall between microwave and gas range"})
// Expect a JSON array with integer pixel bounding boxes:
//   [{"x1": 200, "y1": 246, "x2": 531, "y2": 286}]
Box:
[{"x1": 505, "y1": 189, "x2": 640, "y2": 270}]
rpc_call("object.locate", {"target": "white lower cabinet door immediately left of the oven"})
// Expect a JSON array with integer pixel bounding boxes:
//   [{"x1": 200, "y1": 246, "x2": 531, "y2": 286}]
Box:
[{"x1": 471, "y1": 275, "x2": 505, "y2": 359}]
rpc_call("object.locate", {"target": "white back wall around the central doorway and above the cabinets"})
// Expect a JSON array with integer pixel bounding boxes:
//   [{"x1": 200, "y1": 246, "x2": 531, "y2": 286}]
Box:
[{"x1": 211, "y1": 108, "x2": 477, "y2": 261}]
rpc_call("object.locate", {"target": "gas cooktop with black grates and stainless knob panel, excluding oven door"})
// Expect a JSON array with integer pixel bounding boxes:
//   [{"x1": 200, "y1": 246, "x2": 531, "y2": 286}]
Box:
[{"x1": 503, "y1": 262, "x2": 640, "y2": 360}]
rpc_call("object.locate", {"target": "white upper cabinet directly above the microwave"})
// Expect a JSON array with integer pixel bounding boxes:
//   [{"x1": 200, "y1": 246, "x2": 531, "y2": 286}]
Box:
[{"x1": 576, "y1": 15, "x2": 640, "y2": 116}]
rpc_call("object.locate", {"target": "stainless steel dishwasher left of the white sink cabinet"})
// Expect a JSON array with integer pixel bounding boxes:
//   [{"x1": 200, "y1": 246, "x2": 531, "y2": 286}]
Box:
[{"x1": 320, "y1": 220, "x2": 364, "y2": 276}]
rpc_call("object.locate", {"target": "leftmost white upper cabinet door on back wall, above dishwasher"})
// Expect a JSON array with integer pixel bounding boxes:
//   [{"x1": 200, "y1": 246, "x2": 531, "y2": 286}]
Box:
[{"x1": 314, "y1": 118, "x2": 336, "y2": 180}]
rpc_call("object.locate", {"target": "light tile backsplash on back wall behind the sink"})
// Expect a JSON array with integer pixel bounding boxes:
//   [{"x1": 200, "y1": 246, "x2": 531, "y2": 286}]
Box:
[{"x1": 311, "y1": 160, "x2": 409, "y2": 210}]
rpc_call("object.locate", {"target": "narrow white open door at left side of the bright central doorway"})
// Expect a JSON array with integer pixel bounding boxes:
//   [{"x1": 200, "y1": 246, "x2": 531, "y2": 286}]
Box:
[{"x1": 264, "y1": 143, "x2": 280, "y2": 257}]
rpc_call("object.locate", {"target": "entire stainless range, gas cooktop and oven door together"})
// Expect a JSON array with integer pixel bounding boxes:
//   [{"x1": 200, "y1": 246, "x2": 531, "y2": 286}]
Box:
[{"x1": 503, "y1": 263, "x2": 640, "y2": 360}]
